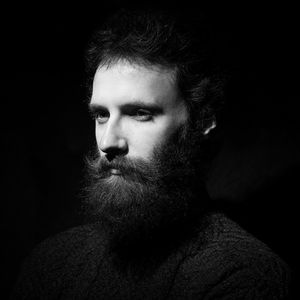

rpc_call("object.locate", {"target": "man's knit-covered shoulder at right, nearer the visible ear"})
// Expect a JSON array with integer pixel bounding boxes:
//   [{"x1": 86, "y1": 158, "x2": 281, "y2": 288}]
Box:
[{"x1": 171, "y1": 214, "x2": 290, "y2": 299}]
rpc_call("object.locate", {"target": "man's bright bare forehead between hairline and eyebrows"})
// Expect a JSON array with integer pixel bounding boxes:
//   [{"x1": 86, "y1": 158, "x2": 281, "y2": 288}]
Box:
[{"x1": 91, "y1": 62, "x2": 179, "y2": 105}]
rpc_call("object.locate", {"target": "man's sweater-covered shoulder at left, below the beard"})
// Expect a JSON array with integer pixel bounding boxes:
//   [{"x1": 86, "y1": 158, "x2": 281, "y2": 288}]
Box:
[{"x1": 13, "y1": 225, "x2": 102, "y2": 299}]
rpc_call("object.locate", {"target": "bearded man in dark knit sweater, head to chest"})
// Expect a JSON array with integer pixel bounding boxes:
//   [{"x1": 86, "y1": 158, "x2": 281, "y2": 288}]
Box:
[{"x1": 13, "y1": 11, "x2": 289, "y2": 299}]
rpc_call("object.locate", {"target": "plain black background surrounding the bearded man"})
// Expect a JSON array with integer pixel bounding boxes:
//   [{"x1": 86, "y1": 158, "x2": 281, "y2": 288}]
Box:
[{"x1": 1, "y1": 1, "x2": 300, "y2": 293}]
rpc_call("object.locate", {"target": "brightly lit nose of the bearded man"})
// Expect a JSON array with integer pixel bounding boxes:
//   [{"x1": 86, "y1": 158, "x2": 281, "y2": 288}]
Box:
[{"x1": 99, "y1": 122, "x2": 128, "y2": 160}]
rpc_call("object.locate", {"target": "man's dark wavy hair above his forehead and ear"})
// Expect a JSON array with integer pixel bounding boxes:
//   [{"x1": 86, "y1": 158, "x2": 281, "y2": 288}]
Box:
[{"x1": 86, "y1": 10, "x2": 225, "y2": 130}]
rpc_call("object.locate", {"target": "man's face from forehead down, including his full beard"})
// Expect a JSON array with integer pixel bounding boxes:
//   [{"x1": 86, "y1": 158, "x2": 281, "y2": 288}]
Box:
[{"x1": 87, "y1": 62, "x2": 210, "y2": 251}]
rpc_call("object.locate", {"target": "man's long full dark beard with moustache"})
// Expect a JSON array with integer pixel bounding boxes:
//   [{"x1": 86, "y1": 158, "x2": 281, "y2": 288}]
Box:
[{"x1": 86, "y1": 122, "x2": 209, "y2": 256}]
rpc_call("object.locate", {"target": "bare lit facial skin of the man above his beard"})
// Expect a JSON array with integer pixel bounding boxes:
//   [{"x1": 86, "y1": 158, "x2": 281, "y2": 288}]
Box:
[{"x1": 90, "y1": 62, "x2": 188, "y2": 160}]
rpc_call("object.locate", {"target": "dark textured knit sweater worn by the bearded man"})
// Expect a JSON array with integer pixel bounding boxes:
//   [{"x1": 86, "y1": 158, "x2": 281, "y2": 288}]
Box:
[{"x1": 13, "y1": 214, "x2": 289, "y2": 300}]
